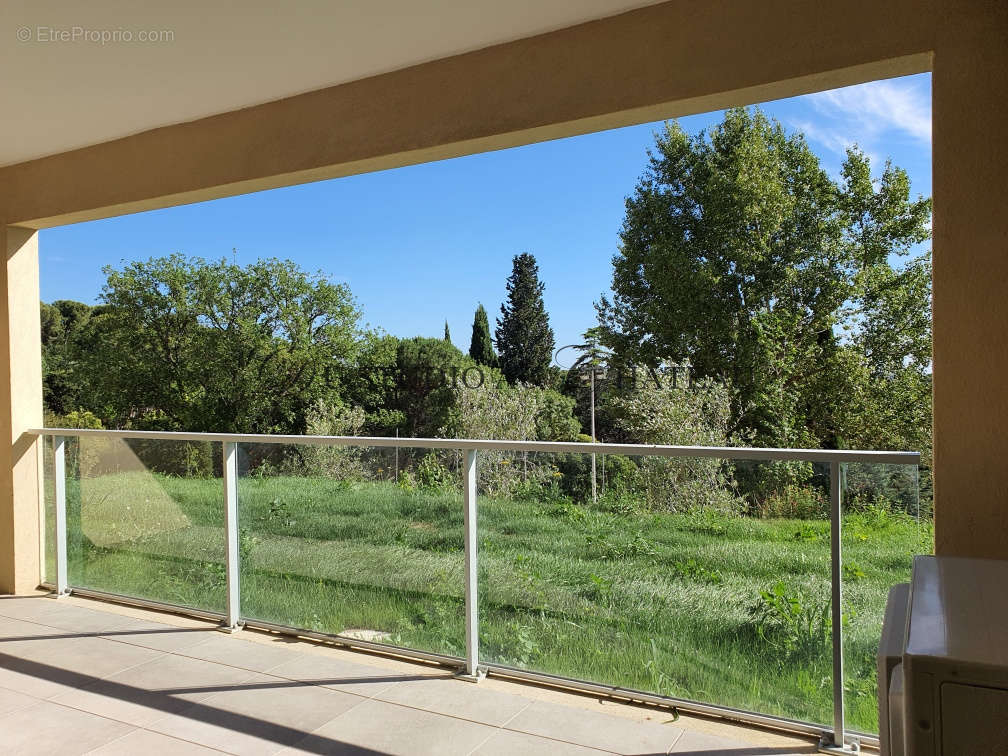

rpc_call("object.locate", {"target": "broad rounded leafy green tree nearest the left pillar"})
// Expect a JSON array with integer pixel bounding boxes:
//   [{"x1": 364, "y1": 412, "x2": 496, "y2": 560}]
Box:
[{"x1": 75, "y1": 255, "x2": 359, "y2": 432}]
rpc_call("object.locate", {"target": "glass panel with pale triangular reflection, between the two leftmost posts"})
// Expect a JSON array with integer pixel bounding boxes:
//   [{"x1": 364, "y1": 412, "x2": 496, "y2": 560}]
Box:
[{"x1": 67, "y1": 436, "x2": 226, "y2": 611}]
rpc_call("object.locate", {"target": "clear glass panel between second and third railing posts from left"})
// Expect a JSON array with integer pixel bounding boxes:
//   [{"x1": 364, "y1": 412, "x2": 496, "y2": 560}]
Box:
[{"x1": 238, "y1": 444, "x2": 466, "y2": 656}]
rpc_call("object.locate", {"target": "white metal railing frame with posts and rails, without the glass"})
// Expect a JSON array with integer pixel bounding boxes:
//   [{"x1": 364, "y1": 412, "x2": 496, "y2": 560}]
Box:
[{"x1": 29, "y1": 428, "x2": 920, "y2": 753}]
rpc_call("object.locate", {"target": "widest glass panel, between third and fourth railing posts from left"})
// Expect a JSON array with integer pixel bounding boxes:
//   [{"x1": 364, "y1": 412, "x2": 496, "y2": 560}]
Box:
[{"x1": 479, "y1": 454, "x2": 838, "y2": 724}]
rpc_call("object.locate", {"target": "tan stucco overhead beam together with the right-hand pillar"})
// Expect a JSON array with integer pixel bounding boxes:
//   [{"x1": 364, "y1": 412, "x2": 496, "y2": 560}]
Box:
[{"x1": 0, "y1": 0, "x2": 1008, "y2": 585}]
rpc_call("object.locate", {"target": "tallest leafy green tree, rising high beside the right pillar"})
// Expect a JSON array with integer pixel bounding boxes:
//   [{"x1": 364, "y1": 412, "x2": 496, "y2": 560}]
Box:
[{"x1": 599, "y1": 109, "x2": 930, "y2": 455}]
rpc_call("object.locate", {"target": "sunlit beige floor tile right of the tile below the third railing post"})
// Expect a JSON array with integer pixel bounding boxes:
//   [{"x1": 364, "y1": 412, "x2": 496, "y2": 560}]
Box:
[{"x1": 507, "y1": 701, "x2": 682, "y2": 754}]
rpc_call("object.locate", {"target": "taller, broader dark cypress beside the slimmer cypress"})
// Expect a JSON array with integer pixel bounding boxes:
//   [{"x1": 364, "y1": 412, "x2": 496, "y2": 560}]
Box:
[{"x1": 497, "y1": 252, "x2": 555, "y2": 386}]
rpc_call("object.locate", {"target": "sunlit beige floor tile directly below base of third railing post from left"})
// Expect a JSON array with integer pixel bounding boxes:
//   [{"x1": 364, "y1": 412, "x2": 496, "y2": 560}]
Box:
[{"x1": 375, "y1": 674, "x2": 532, "y2": 727}]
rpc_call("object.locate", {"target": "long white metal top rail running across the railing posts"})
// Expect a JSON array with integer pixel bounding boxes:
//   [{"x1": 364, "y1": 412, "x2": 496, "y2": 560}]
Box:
[{"x1": 28, "y1": 427, "x2": 920, "y2": 465}]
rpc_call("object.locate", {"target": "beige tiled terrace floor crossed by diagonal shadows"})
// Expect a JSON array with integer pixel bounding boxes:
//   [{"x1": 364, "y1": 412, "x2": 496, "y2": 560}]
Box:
[{"x1": 0, "y1": 596, "x2": 814, "y2": 756}]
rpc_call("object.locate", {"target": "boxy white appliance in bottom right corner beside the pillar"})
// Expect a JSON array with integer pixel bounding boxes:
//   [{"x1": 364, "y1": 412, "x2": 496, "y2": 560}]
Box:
[{"x1": 878, "y1": 556, "x2": 1008, "y2": 756}]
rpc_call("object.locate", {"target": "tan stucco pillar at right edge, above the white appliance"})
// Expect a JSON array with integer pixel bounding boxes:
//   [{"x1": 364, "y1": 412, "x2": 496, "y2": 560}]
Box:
[{"x1": 931, "y1": 2, "x2": 1008, "y2": 558}]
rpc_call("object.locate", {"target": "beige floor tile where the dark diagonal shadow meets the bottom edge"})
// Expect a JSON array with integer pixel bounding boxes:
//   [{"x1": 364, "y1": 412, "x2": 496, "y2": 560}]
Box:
[{"x1": 283, "y1": 700, "x2": 495, "y2": 756}]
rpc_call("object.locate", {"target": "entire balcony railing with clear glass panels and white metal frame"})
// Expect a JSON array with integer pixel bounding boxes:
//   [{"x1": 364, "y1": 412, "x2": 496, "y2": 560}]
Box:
[{"x1": 38, "y1": 429, "x2": 932, "y2": 744}]
